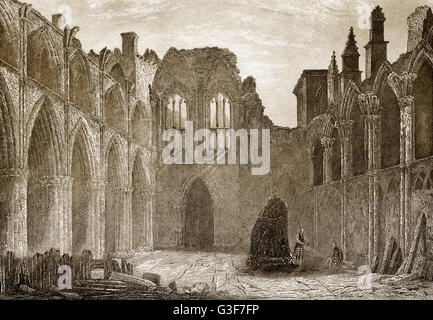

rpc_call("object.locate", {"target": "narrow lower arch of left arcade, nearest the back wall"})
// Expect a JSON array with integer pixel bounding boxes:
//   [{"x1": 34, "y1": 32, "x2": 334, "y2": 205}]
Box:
[{"x1": 131, "y1": 152, "x2": 151, "y2": 249}]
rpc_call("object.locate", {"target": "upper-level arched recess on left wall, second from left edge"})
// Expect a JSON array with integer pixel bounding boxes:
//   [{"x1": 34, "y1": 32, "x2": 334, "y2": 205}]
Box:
[{"x1": 27, "y1": 27, "x2": 62, "y2": 92}]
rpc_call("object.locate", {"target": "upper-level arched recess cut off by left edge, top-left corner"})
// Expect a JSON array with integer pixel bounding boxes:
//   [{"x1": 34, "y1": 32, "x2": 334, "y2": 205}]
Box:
[{"x1": 0, "y1": 7, "x2": 19, "y2": 67}]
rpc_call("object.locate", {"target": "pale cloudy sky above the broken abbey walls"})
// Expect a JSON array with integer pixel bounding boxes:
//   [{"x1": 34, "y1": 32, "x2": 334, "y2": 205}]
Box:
[{"x1": 27, "y1": 0, "x2": 433, "y2": 127}]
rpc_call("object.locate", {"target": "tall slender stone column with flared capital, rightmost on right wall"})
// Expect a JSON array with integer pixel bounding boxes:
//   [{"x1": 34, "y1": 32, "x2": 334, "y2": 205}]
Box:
[{"x1": 388, "y1": 72, "x2": 417, "y2": 257}]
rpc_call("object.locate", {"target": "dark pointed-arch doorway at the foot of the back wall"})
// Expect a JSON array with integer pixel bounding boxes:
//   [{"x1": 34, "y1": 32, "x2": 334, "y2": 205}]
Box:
[{"x1": 185, "y1": 179, "x2": 214, "y2": 249}]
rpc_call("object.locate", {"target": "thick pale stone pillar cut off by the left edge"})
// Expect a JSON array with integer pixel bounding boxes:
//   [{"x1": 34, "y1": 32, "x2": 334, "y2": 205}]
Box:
[{"x1": 0, "y1": 169, "x2": 27, "y2": 257}]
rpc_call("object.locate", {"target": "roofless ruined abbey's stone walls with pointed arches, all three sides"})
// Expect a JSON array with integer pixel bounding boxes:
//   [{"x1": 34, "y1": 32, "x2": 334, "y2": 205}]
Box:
[{"x1": 0, "y1": 0, "x2": 433, "y2": 278}]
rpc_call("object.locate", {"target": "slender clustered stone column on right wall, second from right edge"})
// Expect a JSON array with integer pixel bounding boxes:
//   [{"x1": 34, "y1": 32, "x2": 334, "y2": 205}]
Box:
[{"x1": 358, "y1": 92, "x2": 381, "y2": 263}]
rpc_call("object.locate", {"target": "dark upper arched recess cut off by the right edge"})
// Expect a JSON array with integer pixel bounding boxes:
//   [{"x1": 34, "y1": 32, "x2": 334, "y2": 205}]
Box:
[{"x1": 413, "y1": 61, "x2": 433, "y2": 159}]
